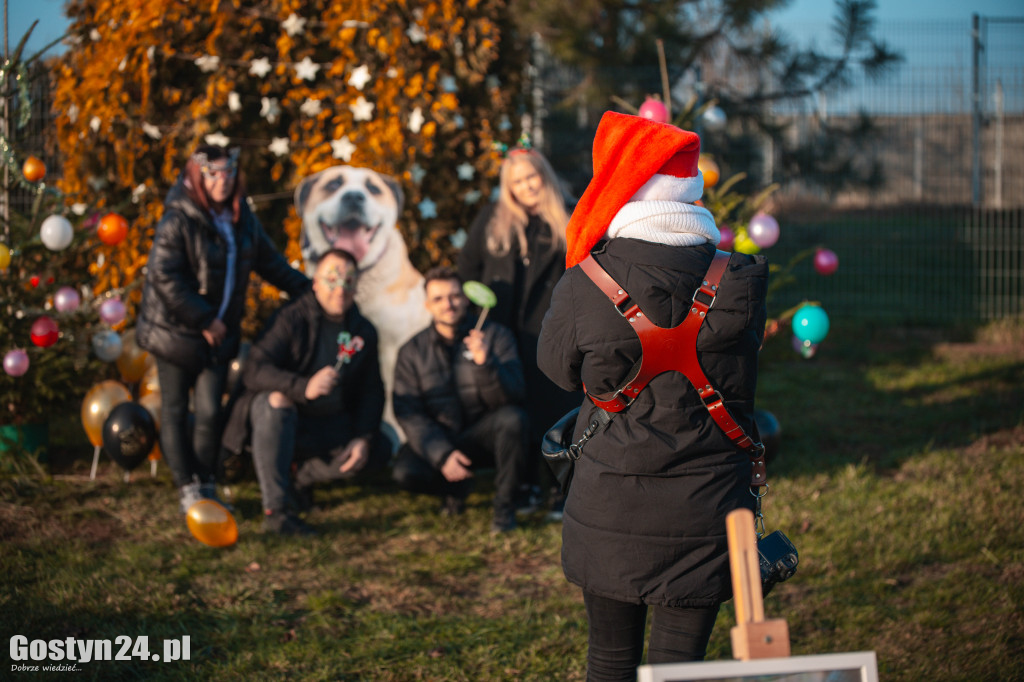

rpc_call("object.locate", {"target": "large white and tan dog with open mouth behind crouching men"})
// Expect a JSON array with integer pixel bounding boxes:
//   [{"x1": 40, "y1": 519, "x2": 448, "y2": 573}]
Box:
[{"x1": 295, "y1": 166, "x2": 430, "y2": 438}]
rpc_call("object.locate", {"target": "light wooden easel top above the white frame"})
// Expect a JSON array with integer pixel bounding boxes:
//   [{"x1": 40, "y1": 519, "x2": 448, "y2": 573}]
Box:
[{"x1": 725, "y1": 509, "x2": 790, "y2": 660}]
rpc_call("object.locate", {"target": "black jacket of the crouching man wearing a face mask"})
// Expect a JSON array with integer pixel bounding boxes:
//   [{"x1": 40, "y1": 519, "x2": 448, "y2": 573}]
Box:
[{"x1": 222, "y1": 291, "x2": 384, "y2": 453}]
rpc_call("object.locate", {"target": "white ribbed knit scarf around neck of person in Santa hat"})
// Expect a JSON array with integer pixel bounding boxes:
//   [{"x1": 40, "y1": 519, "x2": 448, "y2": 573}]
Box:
[{"x1": 605, "y1": 202, "x2": 722, "y2": 246}]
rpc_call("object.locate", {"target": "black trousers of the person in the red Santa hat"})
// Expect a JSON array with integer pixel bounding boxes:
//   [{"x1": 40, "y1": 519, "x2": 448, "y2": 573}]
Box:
[{"x1": 583, "y1": 592, "x2": 719, "y2": 682}]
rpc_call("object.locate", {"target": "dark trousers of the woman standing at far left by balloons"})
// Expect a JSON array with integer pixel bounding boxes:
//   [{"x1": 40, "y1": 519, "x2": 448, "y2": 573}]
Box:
[{"x1": 157, "y1": 357, "x2": 227, "y2": 487}]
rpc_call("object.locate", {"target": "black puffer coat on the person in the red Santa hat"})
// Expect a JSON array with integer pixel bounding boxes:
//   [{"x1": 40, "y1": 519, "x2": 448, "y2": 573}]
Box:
[{"x1": 539, "y1": 239, "x2": 768, "y2": 606}]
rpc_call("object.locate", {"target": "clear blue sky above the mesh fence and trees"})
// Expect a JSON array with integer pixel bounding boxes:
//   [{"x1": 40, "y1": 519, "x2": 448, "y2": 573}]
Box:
[{"x1": 0, "y1": 0, "x2": 1024, "y2": 54}]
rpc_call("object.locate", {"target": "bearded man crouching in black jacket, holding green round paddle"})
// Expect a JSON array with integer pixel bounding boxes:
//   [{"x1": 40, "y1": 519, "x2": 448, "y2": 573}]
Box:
[{"x1": 392, "y1": 267, "x2": 527, "y2": 532}]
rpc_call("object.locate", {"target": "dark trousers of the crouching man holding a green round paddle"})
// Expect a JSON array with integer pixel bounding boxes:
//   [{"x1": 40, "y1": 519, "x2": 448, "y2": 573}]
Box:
[{"x1": 391, "y1": 406, "x2": 527, "y2": 510}]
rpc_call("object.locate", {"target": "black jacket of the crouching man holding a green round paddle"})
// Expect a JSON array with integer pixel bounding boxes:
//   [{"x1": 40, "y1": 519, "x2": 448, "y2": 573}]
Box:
[{"x1": 393, "y1": 321, "x2": 525, "y2": 469}]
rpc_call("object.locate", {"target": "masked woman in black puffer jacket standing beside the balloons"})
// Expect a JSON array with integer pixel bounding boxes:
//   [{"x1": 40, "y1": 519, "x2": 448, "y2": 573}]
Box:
[{"x1": 136, "y1": 146, "x2": 309, "y2": 513}]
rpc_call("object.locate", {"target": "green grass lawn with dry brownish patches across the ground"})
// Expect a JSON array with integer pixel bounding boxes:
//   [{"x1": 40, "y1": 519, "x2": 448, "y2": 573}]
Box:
[{"x1": 0, "y1": 325, "x2": 1024, "y2": 680}]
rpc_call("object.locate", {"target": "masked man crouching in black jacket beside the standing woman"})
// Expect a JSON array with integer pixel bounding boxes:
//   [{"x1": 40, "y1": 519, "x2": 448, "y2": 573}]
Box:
[{"x1": 223, "y1": 249, "x2": 390, "y2": 535}]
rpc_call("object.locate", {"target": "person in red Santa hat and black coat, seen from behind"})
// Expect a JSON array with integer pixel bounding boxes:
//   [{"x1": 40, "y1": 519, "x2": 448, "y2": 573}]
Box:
[{"x1": 539, "y1": 113, "x2": 768, "y2": 680}]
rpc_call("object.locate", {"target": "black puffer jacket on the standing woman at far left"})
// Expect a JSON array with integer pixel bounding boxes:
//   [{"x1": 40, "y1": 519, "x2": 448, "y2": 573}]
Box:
[{"x1": 135, "y1": 178, "x2": 309, "y2": 370}]
